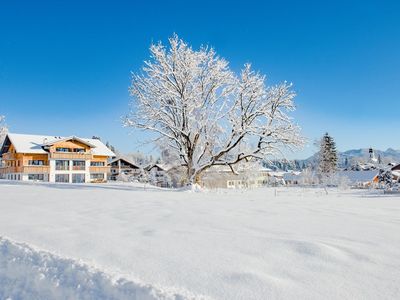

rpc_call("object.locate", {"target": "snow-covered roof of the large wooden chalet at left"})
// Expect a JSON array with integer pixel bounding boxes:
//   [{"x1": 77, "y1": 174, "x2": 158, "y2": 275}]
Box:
[{"x1": 3, "y1": 133, "x2": 115, "y2": 156}]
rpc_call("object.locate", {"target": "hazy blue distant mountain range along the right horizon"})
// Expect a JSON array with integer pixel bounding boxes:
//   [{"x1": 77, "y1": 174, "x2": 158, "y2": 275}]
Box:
[{"x1": 263, "y1": 148, "x2": 400, "y2": 171}]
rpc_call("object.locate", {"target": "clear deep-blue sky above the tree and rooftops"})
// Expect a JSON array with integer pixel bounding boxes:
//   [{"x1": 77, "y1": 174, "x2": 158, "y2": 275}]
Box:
[{"x1": 0, "y1": 0, "x2": 400, "y2": 158}]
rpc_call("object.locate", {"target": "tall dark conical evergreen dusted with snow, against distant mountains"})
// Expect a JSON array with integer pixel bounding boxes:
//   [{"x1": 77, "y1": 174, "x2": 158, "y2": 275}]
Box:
[{"x1": 318, "y1": 133, "x2": 338, "y2": 178}]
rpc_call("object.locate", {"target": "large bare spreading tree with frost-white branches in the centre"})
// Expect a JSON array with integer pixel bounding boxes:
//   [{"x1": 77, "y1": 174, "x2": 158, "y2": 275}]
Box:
[{"x1": 124, "y1": 35, "x2": 303, "y2": 184}]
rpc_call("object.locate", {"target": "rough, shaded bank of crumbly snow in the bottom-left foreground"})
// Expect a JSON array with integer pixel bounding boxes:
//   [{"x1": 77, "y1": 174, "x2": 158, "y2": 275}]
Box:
[{"x1": 0, "y1": 236, "x2": 203, "y2": 300}]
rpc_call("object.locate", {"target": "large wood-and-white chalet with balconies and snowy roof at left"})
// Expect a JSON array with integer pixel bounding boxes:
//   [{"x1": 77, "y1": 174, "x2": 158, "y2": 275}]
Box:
[{"x1": 0, "y1": 133, "x2": 115, "y2": 183}]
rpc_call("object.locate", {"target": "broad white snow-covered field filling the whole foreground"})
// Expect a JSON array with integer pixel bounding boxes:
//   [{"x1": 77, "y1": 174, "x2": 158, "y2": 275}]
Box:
[{"x1": 0, "y1": 181, "x2": 400, "y2": 300}]
